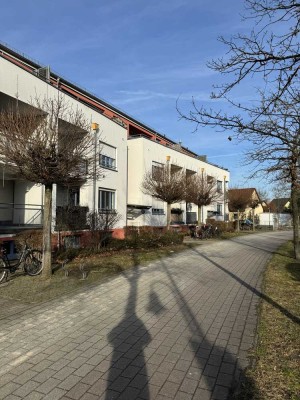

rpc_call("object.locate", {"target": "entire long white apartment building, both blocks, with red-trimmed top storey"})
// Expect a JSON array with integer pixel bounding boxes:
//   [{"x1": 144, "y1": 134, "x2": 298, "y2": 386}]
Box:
[{"x1": 0, "y1": 44, "x2": 230, "y2": 247}]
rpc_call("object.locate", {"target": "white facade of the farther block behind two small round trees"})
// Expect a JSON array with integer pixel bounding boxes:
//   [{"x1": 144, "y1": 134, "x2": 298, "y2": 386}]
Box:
[{"x1": 128, "y1": 137, "x2": 230, "y2": 226}]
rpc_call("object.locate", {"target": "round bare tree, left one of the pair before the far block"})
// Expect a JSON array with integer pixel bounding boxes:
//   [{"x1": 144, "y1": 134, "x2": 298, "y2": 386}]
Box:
[{"x1": 141, "y1": 163, "x2": 186, "y2": 229}]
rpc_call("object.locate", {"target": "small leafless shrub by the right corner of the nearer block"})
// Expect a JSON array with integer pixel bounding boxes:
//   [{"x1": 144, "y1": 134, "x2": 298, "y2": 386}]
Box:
[{"x1": 87, "y1": 210, "x2": 121, "y2": 249}]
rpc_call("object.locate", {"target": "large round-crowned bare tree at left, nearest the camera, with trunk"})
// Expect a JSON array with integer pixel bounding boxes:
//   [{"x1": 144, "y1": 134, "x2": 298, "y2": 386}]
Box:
[{"x1": 0, "y1": 96, "x2": 100, "y2": 277}]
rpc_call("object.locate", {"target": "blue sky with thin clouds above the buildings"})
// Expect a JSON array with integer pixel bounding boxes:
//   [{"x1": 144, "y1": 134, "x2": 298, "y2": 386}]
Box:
[{"x1": 0, "y1": 0, "x2": 272, "y2": 194}]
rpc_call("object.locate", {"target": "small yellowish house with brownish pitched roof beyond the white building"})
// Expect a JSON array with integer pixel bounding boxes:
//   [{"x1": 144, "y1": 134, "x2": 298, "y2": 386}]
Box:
[{"x1": 228, "y1": 188, "x2": 264, "y2": 224}]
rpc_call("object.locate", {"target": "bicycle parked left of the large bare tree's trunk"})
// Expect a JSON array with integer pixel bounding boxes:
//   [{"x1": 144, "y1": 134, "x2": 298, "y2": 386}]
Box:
[{"x1": 0, "y1": 242, "x2": 43, "y2": 283}]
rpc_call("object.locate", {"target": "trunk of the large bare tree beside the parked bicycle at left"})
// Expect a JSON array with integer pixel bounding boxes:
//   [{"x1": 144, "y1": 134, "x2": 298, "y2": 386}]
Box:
[{"x1": 42, "y1": 185, "x2": 52, "y2": 279}]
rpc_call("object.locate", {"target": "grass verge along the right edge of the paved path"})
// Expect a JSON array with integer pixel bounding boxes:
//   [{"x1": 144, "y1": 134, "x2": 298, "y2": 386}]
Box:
[{"x1": 237, "y1": 242, "x2": 300, "y2": 400}]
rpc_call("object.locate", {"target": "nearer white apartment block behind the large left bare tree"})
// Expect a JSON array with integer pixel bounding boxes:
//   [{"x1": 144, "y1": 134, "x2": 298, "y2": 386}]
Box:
[{"x1": 0, "y1": 44, "x2": 127, "y2": 244}]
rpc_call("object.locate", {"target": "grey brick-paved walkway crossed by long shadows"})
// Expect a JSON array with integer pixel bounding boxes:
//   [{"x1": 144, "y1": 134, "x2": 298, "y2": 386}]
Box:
[{"x1": 0, "y1": 232, "x2": 291, "y2": 400}]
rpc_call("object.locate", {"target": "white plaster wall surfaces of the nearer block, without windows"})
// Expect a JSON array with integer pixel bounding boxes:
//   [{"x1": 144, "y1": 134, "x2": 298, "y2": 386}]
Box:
[{"x1": 0, "y1": 57, "x2": 127, "y2": 233}]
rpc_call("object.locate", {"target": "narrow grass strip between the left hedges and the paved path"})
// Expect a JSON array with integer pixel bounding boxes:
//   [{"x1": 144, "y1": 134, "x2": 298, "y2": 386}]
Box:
[{"x1": 0, "y1": 241, "x2": 201, "y2": 303}]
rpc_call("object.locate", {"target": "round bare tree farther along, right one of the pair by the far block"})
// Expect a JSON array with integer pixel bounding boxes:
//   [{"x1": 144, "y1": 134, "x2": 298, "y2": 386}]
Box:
[{"x1": 186, "y1": 173, "x2": 219, "y2": 225}]
